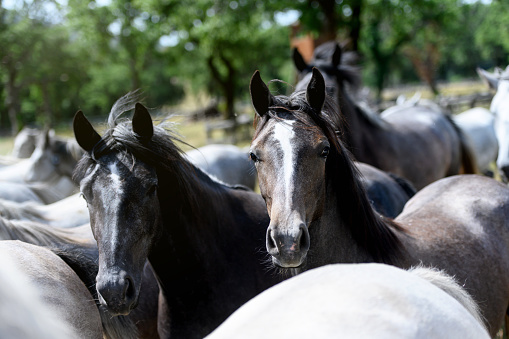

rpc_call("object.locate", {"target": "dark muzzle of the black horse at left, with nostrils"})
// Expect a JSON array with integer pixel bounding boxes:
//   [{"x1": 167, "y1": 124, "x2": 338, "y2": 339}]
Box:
[{"x1": 96, "y1": 271, "x2": 139, "y2": 316}]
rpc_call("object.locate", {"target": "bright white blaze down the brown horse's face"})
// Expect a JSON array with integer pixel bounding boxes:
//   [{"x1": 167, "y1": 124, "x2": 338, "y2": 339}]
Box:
[{"x1": 274, "y1": 120, "x2": 295, "y2": 209}]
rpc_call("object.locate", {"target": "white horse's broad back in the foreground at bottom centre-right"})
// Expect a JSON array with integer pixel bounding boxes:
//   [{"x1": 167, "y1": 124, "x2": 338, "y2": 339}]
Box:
[{"x1": 207, "y1": 264, "x2": 489, "y2": 339}]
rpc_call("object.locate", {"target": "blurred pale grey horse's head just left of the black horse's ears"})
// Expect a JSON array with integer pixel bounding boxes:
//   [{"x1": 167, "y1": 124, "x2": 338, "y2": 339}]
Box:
[{"x1": 25, "y1": 130, "x2": 83, "y2": 183}]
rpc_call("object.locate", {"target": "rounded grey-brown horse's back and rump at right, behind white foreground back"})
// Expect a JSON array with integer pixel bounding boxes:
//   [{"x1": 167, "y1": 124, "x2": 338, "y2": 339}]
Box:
[{"x1": 396, "y1": 175, "x2": 509, "y2": 335}]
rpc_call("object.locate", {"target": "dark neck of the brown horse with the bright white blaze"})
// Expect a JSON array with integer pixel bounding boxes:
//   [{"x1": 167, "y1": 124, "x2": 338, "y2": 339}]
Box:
[{"x1": 310, "y1": 163, "x2": 405, "y2": 267}]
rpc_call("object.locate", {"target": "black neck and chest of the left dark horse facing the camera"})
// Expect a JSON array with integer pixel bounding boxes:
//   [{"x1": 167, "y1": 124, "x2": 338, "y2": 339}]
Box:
[{"x1": 145, "y1": 164, "x2": 274, "y2": 337}]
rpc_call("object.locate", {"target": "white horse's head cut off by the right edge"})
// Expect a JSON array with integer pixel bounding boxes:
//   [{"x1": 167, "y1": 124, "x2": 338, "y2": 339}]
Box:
[{"x1": 477, "y1": 66, "x2": 509, "y2": 181}]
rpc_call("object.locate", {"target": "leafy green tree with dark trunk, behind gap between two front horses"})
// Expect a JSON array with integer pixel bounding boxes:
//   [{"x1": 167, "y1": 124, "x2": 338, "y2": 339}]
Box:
[{"x1": 144, "y1": 0, "x2": 290, "y2": 119}]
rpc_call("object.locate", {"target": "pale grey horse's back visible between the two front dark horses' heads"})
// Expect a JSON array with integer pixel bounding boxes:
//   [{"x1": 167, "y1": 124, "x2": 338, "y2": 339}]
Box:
[{"x1": 185, "y1": 144, "x2": 256, "y2": 190}]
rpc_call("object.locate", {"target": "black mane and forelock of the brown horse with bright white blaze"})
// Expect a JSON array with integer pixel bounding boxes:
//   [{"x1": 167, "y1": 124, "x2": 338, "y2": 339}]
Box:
[{"x1": 255, "y1": 91, "x2": 404, "y2": 264}]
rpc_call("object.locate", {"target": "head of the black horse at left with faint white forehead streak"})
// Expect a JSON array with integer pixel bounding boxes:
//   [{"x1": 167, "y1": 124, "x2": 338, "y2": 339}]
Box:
[{"x1": 73, "y1": 103, "x2": 161, "y2": 315}]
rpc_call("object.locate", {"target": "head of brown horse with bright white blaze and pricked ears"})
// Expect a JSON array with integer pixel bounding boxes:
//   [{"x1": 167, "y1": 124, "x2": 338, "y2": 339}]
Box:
[{"x1": 250, "y1": 69, "x2": 338, "y2": 267}]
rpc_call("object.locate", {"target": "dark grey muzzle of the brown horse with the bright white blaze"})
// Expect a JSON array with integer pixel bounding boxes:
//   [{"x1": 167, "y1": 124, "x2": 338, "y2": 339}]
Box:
[{"x1": 266, "y1": 224, "x2": 310, "y2": 267}]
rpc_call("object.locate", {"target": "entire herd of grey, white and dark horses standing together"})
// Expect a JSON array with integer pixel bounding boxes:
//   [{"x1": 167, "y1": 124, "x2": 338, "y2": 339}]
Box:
[{"x1": 0, "y1": 42, "x2": 509, "y2": 338}]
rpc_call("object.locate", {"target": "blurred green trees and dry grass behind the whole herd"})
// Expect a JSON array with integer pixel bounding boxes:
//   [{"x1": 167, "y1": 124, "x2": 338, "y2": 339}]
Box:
[{"x1": 0, "y1": 0, "x2": 509, "y2": 150}]
